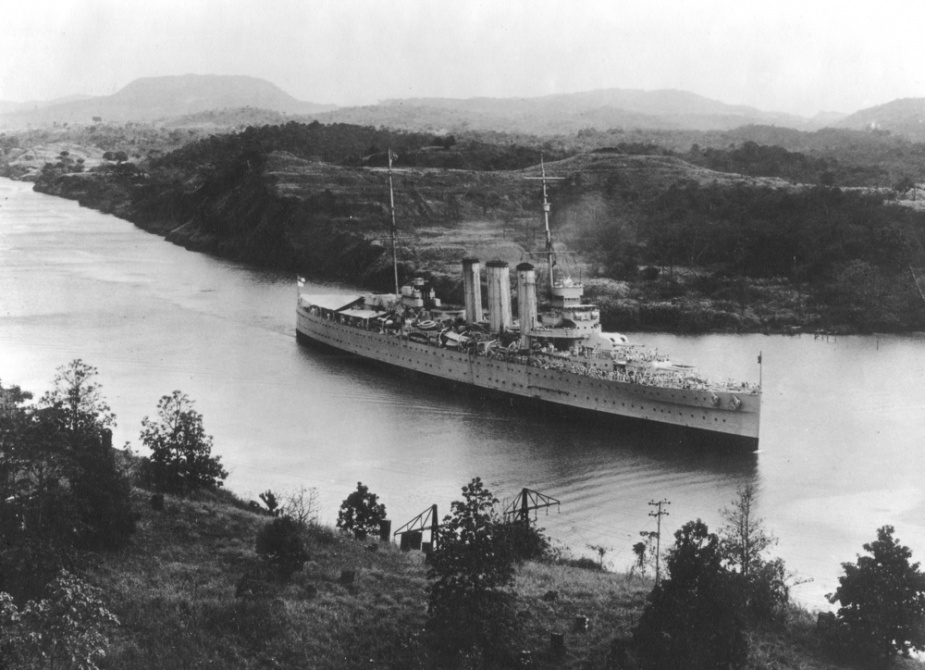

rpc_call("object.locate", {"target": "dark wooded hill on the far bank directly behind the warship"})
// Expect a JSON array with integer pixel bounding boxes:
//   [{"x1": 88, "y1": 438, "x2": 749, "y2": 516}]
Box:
[{"x1": 23, "y1": 123, "x2": 925, "y2": 332}]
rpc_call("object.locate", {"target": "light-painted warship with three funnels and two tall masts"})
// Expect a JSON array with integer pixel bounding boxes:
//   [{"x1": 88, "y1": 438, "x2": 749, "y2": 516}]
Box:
[{"x1": 296, "y1": 153, "x2": 761, "y2": 447}]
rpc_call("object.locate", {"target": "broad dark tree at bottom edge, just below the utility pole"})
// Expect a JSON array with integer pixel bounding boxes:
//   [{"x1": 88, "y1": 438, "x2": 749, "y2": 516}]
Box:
[{"x1": 633, "y1": 519, "x2": 748, "y2": 670}]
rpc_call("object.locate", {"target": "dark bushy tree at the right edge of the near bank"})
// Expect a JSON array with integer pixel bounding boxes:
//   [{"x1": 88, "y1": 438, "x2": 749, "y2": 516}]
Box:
[{"x1": 828, "y1": 526, "x2": 925, "y2": 660}]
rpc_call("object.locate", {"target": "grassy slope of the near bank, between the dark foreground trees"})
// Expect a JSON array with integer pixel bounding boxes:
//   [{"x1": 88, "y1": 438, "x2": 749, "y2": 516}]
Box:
[{"x1": 83, "y1": 491, "x2": 921, "y2": 670}]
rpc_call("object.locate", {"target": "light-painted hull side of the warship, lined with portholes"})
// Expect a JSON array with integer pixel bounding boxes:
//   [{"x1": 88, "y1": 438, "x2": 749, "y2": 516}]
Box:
[{"x1": 296, "y1": 308, "x2": 761, "y2": 447}]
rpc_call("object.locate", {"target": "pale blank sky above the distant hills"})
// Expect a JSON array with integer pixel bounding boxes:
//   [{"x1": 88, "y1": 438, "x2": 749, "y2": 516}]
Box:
[{"x1": 0, "y1": 0, "x2": 925, "y2": 116}]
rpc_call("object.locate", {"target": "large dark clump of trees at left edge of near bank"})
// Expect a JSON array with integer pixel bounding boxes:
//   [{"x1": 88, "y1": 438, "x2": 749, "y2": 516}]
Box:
[{"x1": 0, "y1": 359, "x2": 135, "y2": 599}]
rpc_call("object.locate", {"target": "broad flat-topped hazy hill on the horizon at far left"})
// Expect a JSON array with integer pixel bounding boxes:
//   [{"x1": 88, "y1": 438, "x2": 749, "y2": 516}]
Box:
[{"x1": 0, "y1": 74, "x2": 334, "y2": 128}]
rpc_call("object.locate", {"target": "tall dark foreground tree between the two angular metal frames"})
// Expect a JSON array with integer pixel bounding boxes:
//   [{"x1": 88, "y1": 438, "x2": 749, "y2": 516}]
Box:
[{"x1": 427, "y1": 477, "x2": 515, "y2": 653}]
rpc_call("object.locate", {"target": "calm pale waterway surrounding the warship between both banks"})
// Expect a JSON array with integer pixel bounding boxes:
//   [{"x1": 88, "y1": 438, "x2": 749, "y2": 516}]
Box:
[{"x1": 0, "y1": 180, "x2": 925, "y2": 608}]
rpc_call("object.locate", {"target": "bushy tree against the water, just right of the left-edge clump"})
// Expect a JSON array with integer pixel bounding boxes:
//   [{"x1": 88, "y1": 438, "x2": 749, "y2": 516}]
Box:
[{"x1": 141, "y1": 391, "x2": 228, "y2": 494}]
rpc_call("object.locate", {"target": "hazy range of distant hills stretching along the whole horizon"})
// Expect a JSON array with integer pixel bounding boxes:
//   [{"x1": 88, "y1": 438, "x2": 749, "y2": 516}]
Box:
[{"x1": 7, "y1": 74, "x2": 925, "y2": 141}]
